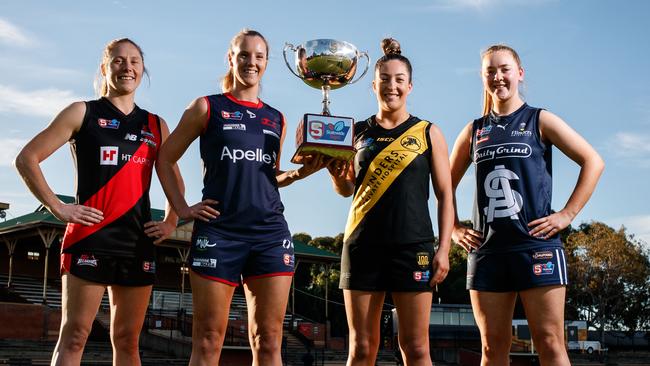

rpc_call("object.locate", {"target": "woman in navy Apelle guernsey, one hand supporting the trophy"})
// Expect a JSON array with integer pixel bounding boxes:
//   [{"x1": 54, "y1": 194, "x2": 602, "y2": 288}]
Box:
[{"x1": 157, "y1": 30, "x2": 325, "y2": 365}]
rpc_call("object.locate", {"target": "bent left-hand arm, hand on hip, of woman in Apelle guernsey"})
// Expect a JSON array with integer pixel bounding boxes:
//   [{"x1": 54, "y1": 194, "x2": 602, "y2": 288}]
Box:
[{"x1": 156, "y1": 98, "x2": 219, "y2": 221}]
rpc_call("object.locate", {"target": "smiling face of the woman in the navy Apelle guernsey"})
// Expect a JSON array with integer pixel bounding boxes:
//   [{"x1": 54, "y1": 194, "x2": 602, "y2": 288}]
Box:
[{"x1": 228, "y1": 36, "x2": 268, "y2": 88}]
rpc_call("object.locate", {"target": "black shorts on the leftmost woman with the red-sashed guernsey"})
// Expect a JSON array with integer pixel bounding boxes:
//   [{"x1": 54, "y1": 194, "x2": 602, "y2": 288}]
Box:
[{"x1": 61, "y1": 253, "x2": 156, "y2": 286}]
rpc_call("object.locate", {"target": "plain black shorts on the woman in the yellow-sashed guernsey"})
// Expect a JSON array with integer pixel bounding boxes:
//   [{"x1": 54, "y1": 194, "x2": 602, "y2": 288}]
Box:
[{"x1": 339, "y1": 242, "x2": 433, "y2": 292}]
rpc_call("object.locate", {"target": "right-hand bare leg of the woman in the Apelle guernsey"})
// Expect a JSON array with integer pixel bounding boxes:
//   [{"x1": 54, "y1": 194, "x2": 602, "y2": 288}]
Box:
[{"x1": 244, "y1": 276, "x2": 292, "y2": 366}]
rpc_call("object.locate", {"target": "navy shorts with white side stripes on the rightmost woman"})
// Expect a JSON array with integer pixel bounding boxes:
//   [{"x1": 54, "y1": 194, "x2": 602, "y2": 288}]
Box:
[{"x1": 467, "y1": 247, "x2": 568, "y2": 292}]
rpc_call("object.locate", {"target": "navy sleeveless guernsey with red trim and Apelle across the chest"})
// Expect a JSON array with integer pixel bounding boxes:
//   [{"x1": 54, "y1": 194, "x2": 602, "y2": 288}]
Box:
[{"x1": 197, "y1": 93, "x2": 289, "y2": 241}]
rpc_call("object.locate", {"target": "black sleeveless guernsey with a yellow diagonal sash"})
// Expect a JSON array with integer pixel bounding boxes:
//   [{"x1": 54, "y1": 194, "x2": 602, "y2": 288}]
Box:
[{"x1": 344, "y1": 116, "x2": 434, "y2": 245}]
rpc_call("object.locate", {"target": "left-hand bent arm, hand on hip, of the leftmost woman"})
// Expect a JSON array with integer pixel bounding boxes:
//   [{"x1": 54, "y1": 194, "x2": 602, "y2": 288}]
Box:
[{"x1": 14, "y1": 102, "x2": 104, "y2": 226}]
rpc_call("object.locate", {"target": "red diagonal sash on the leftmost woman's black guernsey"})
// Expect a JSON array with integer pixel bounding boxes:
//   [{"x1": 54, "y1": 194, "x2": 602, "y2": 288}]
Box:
[{"x1": 61, "y1": 114, "x2": 161, "y2": 250}]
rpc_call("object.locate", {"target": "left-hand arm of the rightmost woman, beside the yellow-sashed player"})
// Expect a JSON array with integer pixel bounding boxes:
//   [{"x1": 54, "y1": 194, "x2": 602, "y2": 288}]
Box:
[{"x1": 449, "y1": 122, "x2": 483, "y2": 251}]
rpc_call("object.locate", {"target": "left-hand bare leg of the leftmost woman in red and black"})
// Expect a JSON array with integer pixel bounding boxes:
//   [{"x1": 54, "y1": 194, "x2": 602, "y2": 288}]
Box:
[{"x1": 52, "y1": 273, "x2": 106, "y2": 365}]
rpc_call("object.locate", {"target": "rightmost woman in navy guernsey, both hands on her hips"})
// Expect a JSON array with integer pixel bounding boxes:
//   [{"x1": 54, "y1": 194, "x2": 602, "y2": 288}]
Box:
[{"x1": 450, "y1": 45, "x2": 604, "y2": 366}]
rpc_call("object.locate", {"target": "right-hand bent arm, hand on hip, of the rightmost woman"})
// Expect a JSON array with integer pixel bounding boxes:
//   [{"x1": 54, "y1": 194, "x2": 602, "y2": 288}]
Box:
[{"x1": 528, "y1": 110, "x2": 605, "y2": 238}]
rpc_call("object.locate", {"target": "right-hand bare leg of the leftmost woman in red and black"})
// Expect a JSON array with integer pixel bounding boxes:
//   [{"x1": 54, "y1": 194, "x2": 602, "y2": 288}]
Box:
[{"x1": 108, "y1": 285, "x2": 152, "y2": 366}]
